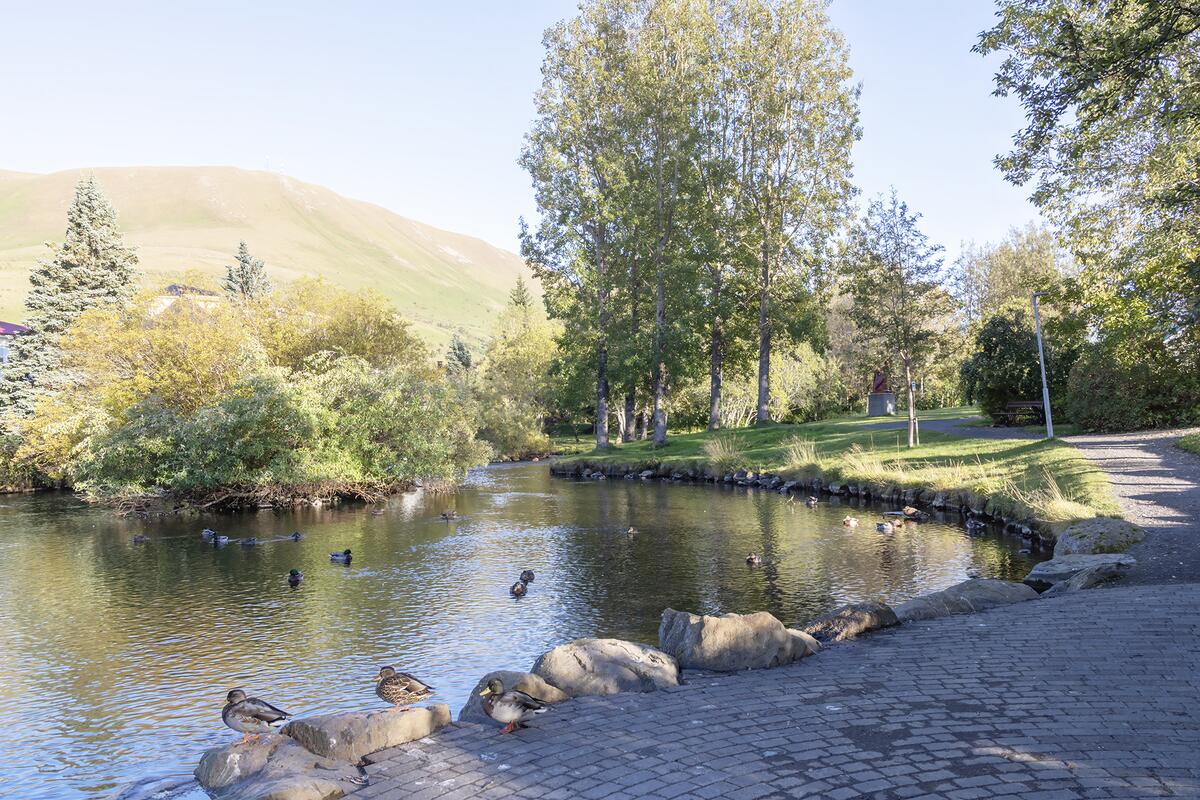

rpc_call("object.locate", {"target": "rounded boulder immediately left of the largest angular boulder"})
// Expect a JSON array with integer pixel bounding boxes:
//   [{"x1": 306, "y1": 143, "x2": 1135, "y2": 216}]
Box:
[{"x1": 530, "y1": 639, "x2": 679, "y2": 697}]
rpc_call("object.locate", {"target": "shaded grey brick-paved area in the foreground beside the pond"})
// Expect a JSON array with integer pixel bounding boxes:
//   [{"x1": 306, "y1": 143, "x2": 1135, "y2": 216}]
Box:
[{"x1": 353, "y1": 585, "x2": 1200, "y2": 800}]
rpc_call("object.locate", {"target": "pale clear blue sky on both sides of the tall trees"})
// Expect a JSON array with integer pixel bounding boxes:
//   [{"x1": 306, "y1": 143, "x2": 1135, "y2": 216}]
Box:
[{"x1": 0, "y1": 0, "x2": 1037, "y2": 262}]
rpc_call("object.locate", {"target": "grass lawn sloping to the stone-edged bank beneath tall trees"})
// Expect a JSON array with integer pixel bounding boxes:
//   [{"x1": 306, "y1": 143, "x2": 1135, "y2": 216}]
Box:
[{"x1": 560, "y1": 408, "x2": 1120, "y2": 523}]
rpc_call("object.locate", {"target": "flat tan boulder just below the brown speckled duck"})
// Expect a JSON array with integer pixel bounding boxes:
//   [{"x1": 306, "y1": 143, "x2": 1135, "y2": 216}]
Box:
[{"x1": 283, "y1": 703, "x2": 450, "y2": 763}]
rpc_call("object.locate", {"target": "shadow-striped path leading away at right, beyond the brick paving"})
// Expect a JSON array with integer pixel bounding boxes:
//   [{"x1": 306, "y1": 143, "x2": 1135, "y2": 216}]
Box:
[{"x1": 1066, "y1": 431, "x2": 1200, "y2": 583}]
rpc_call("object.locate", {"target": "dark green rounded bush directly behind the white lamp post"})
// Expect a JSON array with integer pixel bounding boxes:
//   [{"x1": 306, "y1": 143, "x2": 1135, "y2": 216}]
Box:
[{"x1": 962, "y1": 300, "x2": 1081, "y2": 419}]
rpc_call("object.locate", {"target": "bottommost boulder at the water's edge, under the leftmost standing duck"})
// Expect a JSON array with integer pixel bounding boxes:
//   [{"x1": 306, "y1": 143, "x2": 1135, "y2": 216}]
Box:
[{"x1": 194, "y1": 734, "x2": 362, "y2": 800}]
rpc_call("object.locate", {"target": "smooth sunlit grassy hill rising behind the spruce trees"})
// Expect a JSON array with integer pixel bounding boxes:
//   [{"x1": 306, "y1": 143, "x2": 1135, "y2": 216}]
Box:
[{"x1": 0, "y1": 167, "x2": 529, "y2": 345}]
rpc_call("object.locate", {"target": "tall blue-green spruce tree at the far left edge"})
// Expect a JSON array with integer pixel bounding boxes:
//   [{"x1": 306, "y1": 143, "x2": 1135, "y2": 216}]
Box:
[{"x1": 0, "y1": 175, "x2": 138, "y2": 416}]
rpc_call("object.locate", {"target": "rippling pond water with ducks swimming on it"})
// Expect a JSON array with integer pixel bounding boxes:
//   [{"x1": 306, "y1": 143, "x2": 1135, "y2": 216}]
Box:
[{"x1": 0, "y1": 464, "x2": 1036, "y2": 799}]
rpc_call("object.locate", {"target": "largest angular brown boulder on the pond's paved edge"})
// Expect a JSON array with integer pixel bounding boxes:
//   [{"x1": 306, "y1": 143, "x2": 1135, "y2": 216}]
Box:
[{"x1": 659, "y1": 608, "x2": 820, "y2": 672}]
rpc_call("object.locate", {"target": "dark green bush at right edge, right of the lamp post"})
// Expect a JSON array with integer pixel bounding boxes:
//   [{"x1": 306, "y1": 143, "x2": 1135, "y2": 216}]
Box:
[{"x1": 1067, "y1": 339, "x2": 1200, "y2": 431}]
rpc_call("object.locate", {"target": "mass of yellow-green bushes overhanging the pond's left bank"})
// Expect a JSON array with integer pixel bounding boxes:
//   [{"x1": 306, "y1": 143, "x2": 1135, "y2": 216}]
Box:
[{"x1": 17, "y1": 282, "x2": 488, "y2": 504}]
